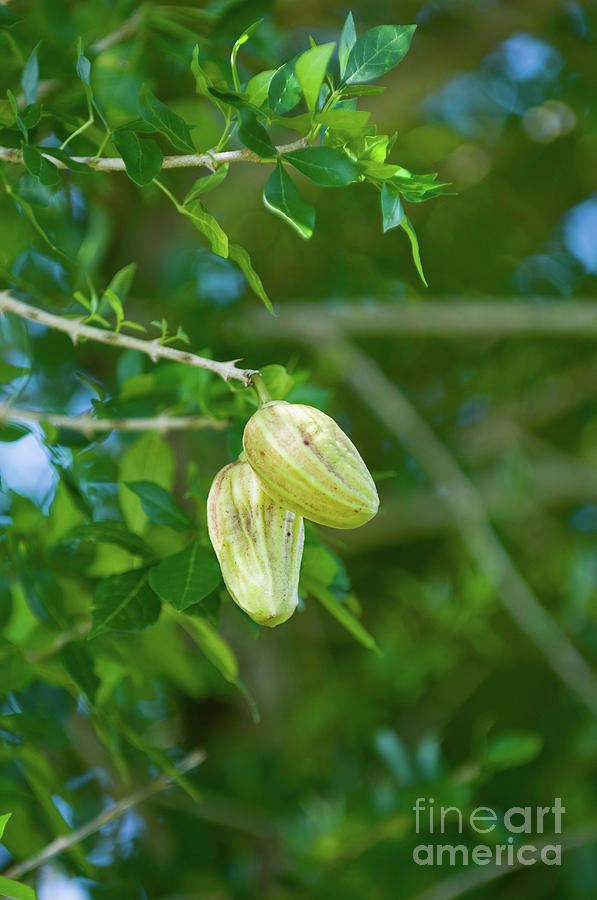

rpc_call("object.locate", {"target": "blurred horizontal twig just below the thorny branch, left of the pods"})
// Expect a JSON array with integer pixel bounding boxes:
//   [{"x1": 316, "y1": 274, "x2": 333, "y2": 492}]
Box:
[{"x1": 0, "y1": 405, "x2": 228, "y2": 436}]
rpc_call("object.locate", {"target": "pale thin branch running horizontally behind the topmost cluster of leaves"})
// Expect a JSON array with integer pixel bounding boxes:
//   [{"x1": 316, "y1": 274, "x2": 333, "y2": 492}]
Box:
[{"x1": 0, "y1": 138, "x2": 307, "y2": 172}]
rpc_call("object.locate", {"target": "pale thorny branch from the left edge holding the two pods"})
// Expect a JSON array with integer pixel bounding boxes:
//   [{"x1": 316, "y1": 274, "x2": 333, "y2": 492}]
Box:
[{"x1": 0, "y1": 292, "x2": 257, "y2": 386}]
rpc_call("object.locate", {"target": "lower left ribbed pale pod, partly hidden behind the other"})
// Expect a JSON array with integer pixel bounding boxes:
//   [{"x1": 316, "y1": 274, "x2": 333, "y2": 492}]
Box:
[{"x1": 207, "y1": 462, "x2": 305, "y2": 627}]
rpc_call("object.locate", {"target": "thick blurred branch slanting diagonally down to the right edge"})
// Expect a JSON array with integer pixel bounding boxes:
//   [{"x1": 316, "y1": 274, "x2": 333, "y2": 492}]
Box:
[{"x1": 320, "y1": 339, "x2": 597, "y2": 716}]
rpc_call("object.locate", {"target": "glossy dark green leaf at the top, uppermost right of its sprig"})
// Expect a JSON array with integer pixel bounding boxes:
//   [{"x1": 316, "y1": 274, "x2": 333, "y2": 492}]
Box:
[{"x1": 342, "y1": 25, "x2": 417, "y2": 85}]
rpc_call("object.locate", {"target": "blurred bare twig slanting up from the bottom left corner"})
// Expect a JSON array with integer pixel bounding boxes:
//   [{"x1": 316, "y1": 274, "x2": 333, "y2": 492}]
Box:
[{"x1": 4, "y1": 750, "x2": 207, "y2": 878}]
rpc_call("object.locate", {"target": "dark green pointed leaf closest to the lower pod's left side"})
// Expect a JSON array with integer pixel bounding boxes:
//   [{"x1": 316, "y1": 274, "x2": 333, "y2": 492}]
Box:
[{"x1": 149, "y1": 541, "x2": 222, "y2": 612}]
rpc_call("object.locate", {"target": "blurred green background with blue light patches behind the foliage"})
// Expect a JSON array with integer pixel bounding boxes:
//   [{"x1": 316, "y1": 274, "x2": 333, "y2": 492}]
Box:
[{"x1": 0, "y1": 0, "x2": 597, "y2": 900}]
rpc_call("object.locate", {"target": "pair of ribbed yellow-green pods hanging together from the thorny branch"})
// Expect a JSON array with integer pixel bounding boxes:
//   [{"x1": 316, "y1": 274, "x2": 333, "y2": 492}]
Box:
[{"x1": 207, "y1": 386, "x2": 379, "y2": 627}]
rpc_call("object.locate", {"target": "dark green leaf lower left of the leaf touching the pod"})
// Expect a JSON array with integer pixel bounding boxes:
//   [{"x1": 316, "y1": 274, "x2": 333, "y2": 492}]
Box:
[{"x1": 89, "y1": 569, "x2": 161, "y2": 638}]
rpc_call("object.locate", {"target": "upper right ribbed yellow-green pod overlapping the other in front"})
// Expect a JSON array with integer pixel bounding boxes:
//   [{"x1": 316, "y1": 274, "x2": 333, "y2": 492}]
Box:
[{"x1": 243, "y1": 400, "x2": 379, "y2": 528}]
